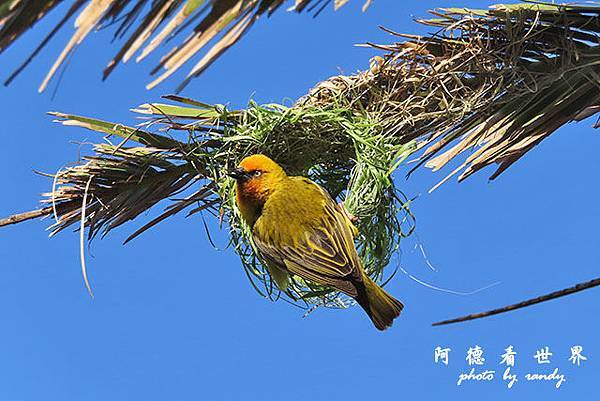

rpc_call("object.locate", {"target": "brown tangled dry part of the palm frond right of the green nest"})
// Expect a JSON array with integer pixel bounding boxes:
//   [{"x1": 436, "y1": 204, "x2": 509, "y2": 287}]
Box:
[{"x1": 303, "y1": 3, "x2": 600, "y2": 189}]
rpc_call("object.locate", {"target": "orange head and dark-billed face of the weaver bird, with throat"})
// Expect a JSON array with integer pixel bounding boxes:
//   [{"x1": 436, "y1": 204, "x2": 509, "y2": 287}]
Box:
[{"x1": 228, "y1": 154, "x2": 287, "y2": 225}]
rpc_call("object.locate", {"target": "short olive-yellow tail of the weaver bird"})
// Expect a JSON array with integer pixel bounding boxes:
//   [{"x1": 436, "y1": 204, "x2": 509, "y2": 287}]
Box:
[{"x1": 356, "y1": 275, "x2": 404, "y2": 330}]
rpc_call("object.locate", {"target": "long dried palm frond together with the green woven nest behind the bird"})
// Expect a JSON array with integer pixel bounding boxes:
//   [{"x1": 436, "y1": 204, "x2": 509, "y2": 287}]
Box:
[{"x1": 0, "y1": 3, "x2": 600, "y2": 307}]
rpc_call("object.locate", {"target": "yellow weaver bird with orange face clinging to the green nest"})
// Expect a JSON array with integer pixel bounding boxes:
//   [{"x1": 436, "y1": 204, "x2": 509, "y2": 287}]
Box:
[{"x1": 229, "y1": 154, "x2": 404, "y2": 330}]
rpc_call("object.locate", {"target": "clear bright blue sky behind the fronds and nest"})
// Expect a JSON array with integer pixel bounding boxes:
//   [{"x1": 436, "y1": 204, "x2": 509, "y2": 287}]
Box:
[{"x1": 0, "y1": 0, "x2": 600, "y2": 401}]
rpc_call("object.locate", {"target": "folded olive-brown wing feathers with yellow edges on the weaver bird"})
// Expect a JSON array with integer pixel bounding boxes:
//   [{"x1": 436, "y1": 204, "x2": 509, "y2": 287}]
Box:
[{"x1": 254, "y1": 188, "x2": 361, "y2": 295}]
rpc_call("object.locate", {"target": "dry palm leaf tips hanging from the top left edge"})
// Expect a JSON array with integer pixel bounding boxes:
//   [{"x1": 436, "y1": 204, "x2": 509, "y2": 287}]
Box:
[{"x1": 0, "y1": 0, "x2": 370, "y2": 92}]
